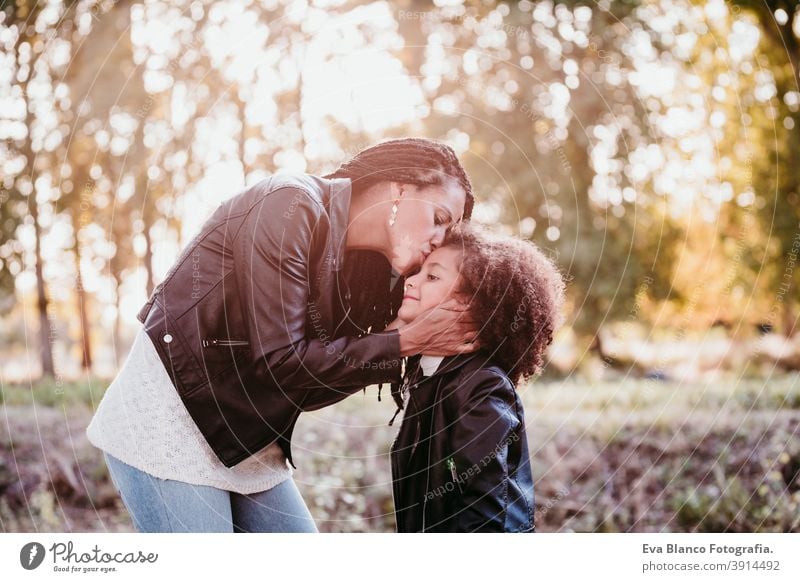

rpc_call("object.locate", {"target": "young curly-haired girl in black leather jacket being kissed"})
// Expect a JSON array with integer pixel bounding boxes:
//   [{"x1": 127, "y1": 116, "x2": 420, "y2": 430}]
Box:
[{"x1": 391, "y1": 225, "x2": 564, "y2": 532}]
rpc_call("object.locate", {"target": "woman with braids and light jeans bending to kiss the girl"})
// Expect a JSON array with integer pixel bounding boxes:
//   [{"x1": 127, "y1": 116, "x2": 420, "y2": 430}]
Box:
[{"x1": 87, "y1": 138, "x2": 475, "y2": 531}]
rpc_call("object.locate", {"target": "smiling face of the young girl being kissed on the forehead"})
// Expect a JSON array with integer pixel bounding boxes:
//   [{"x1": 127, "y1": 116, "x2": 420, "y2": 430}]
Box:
[{"x1": 397, "y1": 247, "x2": 461, "y2": 323}]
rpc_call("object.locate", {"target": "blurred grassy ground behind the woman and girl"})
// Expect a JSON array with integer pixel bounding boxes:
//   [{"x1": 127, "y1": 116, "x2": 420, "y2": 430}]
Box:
[{"x1": 0, "y1": 374, "x2": 800, "y2": 532}]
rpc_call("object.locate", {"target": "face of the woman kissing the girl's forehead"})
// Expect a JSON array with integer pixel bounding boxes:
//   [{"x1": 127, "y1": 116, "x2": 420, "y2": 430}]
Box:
[{"x1": 389, "y1": 180, "x2": 467, "y2": 275}]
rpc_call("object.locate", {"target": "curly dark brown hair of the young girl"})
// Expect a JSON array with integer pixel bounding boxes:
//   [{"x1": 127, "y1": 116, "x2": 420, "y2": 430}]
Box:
[{"x1": 442, "y1": 223, "x2": 565, "y2": 385}]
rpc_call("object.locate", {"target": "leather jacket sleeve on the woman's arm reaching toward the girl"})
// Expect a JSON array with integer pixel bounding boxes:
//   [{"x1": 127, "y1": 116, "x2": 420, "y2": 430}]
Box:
[{"x1": 234, "y1": 187, "x2": 401, "y2": 407}]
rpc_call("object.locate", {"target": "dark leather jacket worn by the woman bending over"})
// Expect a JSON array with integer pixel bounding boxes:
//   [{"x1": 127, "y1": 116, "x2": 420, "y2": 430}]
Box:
[{"x1": 138, "y1": 175, "x2": 401, "y2": 467}]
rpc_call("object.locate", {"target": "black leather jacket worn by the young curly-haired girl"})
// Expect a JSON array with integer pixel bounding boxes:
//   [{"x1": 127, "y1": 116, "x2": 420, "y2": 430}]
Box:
[{"x1": 391, "y1": 352, "x2": 534, "y2": 532}]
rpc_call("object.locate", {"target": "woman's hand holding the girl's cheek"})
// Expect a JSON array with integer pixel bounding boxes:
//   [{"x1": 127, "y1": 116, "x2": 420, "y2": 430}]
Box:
[{"x1": 386, "y1": 299, "x2": 480, "y2": 356}]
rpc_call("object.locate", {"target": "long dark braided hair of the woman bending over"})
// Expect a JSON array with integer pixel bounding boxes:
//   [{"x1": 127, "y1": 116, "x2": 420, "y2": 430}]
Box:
[{"x1": 323, "y1": 137, "x2": 475, "y2": 420}]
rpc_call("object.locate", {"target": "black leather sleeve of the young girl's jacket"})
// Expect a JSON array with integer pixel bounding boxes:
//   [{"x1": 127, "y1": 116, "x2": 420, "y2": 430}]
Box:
[{"x1": 446, "y1": 370, "x2": 519, "y2": 532}]
